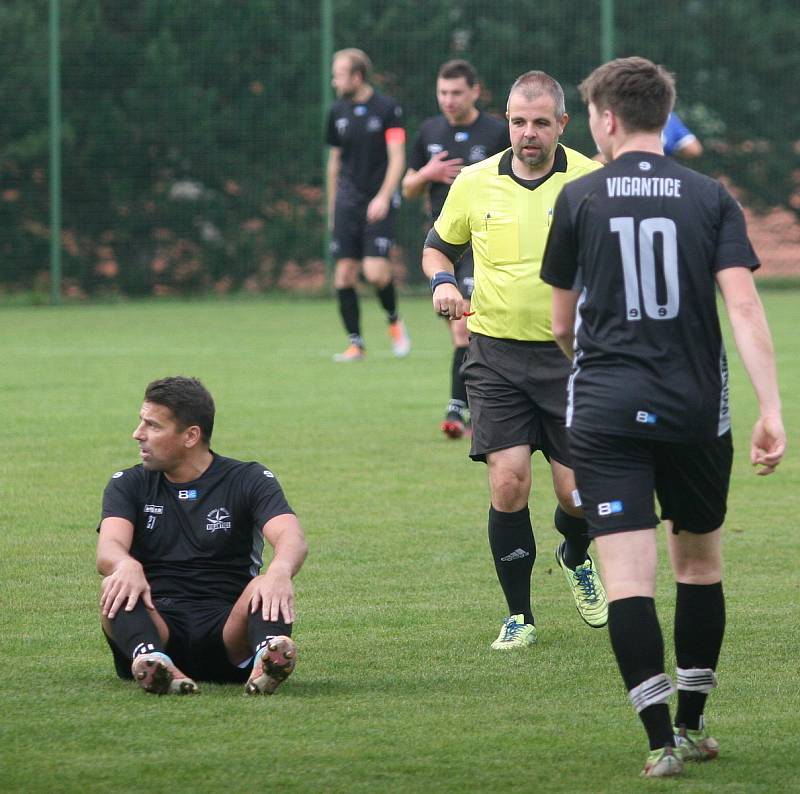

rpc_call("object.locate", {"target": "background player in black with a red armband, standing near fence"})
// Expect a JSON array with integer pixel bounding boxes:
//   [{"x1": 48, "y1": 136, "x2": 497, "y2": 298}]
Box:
[{"x1": 327, "y1": 48, "x2": 411, "y2": 361}]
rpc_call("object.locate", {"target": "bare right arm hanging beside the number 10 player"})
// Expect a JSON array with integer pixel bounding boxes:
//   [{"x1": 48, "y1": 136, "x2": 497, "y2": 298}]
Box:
[{"x1": 717, "y1": 267, "x2": 786, "y2": 475}]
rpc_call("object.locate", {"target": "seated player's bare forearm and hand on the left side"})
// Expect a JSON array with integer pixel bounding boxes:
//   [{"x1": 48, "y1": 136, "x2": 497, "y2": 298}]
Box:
[{"x1": 97, "y1": 517, "x2": 155, "y2": 619}]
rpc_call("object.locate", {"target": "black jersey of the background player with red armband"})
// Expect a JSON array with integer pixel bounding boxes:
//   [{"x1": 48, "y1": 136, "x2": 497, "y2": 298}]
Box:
[{"x1": 326, "y1": 91, "x2": 403, "y2": 202}]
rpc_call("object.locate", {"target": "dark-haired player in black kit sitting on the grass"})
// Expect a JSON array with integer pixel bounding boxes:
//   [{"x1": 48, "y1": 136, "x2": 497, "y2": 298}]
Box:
[{"x1": 97, "y1": 377, "x2": 307, "y2": 694}]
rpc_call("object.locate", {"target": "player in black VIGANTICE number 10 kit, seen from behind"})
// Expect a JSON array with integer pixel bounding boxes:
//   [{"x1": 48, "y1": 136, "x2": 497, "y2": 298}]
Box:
[{"x1": 542, "y1": 58, "x2": 786, "y2": 777}]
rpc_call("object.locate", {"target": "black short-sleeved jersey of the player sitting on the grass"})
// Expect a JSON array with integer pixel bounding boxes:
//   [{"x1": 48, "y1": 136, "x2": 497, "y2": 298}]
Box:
[{"x1": 102, "y1": 453, "x2": 293, "y2": 603}]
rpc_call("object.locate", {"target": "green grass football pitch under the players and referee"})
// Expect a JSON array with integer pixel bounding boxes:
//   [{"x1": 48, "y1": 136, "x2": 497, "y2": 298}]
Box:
[{"x1": 0, "y1": 291, "x2": 800, "y2": 794}]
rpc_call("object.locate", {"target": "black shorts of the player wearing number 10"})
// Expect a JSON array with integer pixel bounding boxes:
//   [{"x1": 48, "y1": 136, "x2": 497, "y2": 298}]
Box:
[{"x1": 569, "y1": 429, "x2": 733, "y2": 537}]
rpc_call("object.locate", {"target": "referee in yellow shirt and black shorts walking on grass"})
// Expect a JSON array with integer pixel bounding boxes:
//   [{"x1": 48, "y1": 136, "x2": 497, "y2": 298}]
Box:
[{"x1": 422, "y1": 71, "x2": 607, "y2": 650}]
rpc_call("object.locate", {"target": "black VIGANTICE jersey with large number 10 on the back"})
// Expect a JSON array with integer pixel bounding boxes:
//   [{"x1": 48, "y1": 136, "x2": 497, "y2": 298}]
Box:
[{"x1": 541, "y1": 152, "x2": 758, "y2": 441}]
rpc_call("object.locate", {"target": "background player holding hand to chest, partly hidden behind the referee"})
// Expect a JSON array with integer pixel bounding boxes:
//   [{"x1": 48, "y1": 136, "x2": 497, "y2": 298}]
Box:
[{"x1": 403, "y1": 60, "x2": 511, "y2": 438}]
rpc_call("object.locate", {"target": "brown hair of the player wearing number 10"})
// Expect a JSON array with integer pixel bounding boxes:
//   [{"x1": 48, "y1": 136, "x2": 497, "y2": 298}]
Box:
[{"x1": 578, "y1": 57, "x2": 675, "y2": 132}]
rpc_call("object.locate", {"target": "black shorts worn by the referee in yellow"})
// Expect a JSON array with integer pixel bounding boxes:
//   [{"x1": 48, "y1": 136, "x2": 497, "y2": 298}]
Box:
[{"x1": 461, "y1": 334, "x2": 571, "y2": 466}]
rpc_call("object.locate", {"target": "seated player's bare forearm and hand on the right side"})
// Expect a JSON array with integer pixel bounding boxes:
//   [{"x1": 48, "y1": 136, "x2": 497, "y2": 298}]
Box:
[{"x1": 250, "y1": 513, "x2": 308, "y2": 623}]
